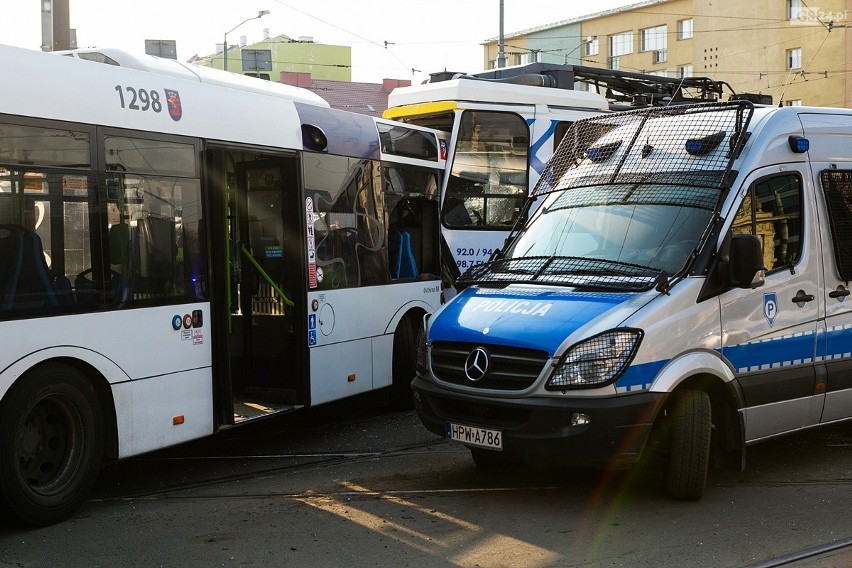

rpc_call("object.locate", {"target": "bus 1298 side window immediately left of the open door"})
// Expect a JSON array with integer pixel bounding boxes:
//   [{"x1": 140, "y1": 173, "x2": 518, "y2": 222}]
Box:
[{"x1": 105, "y1": 136, "x2": 206, "y2": 304}]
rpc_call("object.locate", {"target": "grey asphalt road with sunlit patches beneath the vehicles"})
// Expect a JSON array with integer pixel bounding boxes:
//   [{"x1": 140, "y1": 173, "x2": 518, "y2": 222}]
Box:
[{"x1": 0, "y1": 394, "x2": 852, "y2": 568}]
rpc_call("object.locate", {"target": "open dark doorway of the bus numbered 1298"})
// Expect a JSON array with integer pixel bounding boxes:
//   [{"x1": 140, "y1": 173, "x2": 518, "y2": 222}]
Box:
[{"x1": 228, "y1": 158, "x2": 309, "y2": 420}]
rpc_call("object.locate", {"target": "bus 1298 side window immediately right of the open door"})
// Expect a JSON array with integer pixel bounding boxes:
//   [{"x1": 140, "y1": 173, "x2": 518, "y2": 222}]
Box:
[{"x1": 304, "y1": 154, "x2": 389, "y2": 289}]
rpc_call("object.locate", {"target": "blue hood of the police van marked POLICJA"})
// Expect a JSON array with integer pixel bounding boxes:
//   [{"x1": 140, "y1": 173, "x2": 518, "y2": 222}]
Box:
[{"x1": 429, "y1": 287, "x2": 635, "y2": 356}]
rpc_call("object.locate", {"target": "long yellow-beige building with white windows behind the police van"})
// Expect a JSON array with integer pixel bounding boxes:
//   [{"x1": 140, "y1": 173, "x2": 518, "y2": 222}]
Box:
[{"x1": 484, "y1": 0, "x2": 852, "y2": 107}]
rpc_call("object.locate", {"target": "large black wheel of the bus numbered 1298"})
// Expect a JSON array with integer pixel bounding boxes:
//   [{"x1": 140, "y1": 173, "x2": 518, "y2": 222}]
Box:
[{"x1": 0, "y1": 363, "x2": 105, "y2": 525}]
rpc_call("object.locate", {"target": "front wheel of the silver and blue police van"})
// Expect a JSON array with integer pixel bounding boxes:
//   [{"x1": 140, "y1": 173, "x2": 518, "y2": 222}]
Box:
[{"x1": 666, "y1": 389, "x2": 713, "y2": 501}]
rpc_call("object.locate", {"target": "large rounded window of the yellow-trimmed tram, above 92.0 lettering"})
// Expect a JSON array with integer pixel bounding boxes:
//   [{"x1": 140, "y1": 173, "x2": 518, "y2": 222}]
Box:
[{"x1": 442, "y1": 110, "x2": 530, "y2": 230}]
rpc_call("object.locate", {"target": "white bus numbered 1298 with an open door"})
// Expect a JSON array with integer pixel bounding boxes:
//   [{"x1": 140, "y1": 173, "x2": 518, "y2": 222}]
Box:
[{"x1": 0, "y1": 46, "x2": 446, "y2": 525}]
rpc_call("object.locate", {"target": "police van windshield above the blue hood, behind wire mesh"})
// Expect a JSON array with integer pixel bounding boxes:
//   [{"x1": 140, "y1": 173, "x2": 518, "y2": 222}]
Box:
[{"x1": 505, "y1": 184, "x2": 719, "y2": 274}]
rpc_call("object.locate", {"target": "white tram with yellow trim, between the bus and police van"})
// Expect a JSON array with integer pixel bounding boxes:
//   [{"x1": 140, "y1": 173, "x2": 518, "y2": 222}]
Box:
[{"x1": 384, "y1": 63, "x2": 730, "y2": 280}]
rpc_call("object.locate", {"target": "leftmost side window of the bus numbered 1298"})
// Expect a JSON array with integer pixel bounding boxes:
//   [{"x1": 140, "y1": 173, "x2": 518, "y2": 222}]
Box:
[{"x1": 0, "y1": 124, "x2": 94, "y2": 314}]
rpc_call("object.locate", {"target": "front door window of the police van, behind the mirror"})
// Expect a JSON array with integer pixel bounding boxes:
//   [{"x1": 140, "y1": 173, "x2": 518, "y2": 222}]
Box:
[{"x1": 732, "y1": 174, "x2": 802, "y2": 272}]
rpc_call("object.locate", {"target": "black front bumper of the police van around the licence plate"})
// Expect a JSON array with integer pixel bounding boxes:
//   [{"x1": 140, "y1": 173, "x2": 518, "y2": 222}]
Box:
[{"x1": 412, "y1": 377, "x2": 666, "y2": 468}]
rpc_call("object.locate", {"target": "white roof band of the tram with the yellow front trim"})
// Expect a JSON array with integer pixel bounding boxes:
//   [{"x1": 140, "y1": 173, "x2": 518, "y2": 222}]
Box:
[{"x1": 385, "y1": 79, "x2": 609, "y2": 118}]
